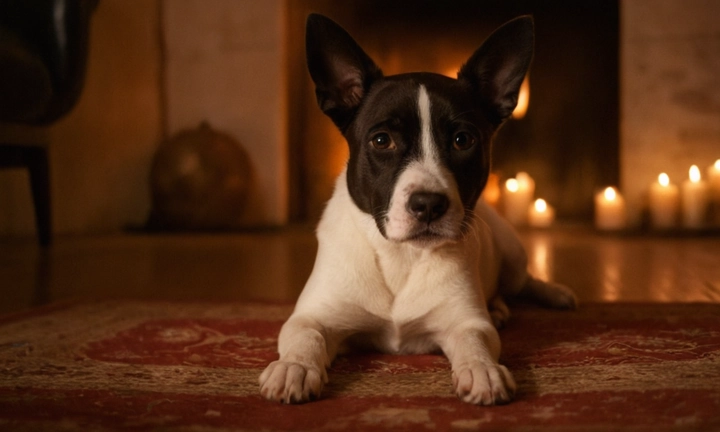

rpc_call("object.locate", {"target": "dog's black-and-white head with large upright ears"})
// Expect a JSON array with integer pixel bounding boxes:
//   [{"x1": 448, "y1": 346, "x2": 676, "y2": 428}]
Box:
[{"x1": 306, "y1": 15, "x2": 533, "y2": 245}]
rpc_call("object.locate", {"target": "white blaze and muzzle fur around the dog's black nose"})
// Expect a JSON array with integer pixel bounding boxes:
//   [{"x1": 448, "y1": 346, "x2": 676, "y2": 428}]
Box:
[{"x1": 385, "y1": 85, "x2": 464, "y2": 241}]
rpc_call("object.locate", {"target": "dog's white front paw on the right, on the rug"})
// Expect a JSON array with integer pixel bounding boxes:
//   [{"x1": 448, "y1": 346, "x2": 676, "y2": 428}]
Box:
[{"x1": 453, "y1": 362, "x2": 516, "y2": 405}]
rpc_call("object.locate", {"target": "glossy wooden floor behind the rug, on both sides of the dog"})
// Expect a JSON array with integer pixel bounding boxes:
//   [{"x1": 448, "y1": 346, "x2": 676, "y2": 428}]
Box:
[{"x1": 0, "y1": 227, "x2": 720, "y2": 313}]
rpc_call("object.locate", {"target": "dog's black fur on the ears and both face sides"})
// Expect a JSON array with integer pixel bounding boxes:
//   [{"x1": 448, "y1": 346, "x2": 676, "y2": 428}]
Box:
[{"x1": 306, "y1": 14, "x2": 534, "y2": 234}]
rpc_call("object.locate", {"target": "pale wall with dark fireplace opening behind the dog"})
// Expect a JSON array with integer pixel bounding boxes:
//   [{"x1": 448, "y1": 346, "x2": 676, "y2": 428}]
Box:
[{"x1": 0, "y1": 0, "x2": 720, "y2": 235}]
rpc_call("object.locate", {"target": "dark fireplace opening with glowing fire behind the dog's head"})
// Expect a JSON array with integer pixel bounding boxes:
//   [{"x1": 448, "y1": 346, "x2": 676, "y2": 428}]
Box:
[{"x1": 286, "y1": 0, "x2": 619, "y2": 222}]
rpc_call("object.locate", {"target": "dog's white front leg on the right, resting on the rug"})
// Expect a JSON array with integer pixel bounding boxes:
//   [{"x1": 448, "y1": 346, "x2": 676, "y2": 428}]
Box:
[{"x1": 441, "y1": 319, "x2": 516, "y2": 405}]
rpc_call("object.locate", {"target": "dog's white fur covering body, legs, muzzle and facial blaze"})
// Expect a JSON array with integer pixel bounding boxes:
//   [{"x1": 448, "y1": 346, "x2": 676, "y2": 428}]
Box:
[{"x1": 260, "y1": 87, "x2": 574, "y2": 405}]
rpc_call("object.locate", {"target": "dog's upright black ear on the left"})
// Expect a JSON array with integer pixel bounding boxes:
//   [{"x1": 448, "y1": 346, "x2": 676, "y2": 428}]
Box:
[{"x1": 305, "y1": 14, "x2": 382, "y2": 132}]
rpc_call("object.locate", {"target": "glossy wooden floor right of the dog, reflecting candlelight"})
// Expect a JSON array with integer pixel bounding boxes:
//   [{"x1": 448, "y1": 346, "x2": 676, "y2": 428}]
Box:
[{"x1": 521, "y1": 229, "x2": 720, "y2": 302}]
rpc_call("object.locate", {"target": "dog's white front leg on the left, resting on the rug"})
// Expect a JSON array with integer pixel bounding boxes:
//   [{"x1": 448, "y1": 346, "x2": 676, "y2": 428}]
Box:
[{"x1": 259, "y1": 315, "x2": 338, "y2": 404}]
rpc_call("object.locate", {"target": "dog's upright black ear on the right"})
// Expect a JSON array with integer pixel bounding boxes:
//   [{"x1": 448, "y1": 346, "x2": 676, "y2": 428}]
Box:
[{"x1": 458, "y1": 16, "x2": 535, "y2": 125}]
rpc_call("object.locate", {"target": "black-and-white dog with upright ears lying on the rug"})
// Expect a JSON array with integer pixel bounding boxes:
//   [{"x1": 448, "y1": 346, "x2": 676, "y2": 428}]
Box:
[{"x1": 259, "y1": 14, "x2": 576, "y2": 405}]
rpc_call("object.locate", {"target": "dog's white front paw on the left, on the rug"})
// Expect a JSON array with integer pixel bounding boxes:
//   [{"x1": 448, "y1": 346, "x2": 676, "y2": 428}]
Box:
[{"x1": 259, "y1": 360, "x2": 327, "y2": 404}]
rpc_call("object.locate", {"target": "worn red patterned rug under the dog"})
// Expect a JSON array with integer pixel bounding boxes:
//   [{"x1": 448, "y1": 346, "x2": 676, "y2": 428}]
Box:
[{"x1": 0, "y1": 302, "x2": 720, "y2": 431}]
